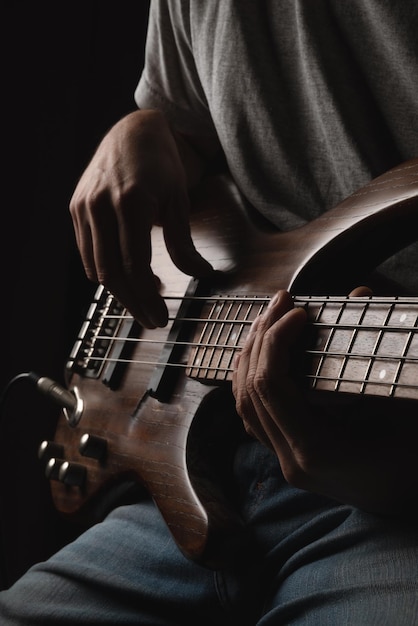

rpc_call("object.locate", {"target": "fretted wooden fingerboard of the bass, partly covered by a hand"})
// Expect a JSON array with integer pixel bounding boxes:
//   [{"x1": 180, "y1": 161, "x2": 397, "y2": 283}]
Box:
[{"x1": 188, "y1": 296, "x2": 418, "y2": 399}]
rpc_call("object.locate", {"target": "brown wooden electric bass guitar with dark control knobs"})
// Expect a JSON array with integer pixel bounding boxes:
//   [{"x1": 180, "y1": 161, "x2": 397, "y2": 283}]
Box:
[{"x1": 41, "y1": 159, "x2": 418, "y2": 567}]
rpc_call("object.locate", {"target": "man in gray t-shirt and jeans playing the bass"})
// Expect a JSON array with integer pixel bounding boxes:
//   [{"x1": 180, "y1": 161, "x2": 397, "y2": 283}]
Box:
[{"x1": 0, "y1": 0, "x2": 418, "y2": 625}]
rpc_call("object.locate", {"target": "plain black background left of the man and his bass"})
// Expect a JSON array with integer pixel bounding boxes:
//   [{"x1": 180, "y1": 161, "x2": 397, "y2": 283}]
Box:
[{"x1": 0, "y1": 0, "x2": 149, "y2": 586}]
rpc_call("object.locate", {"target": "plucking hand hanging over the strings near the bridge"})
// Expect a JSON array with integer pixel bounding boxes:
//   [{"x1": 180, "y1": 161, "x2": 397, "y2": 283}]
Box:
[{"x1": 70, "y1": 111, "x2": 212, "y2": 328}]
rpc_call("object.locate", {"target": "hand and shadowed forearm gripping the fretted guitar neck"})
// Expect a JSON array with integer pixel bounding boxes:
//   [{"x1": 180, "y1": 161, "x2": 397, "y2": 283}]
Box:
[{"x1": 233, "y1": 288, "x2": 418, "y2": 514}]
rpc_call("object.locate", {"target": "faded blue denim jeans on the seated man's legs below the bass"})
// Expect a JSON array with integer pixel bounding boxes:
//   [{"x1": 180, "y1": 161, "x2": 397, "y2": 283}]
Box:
[{"x1": 0, "y1": 440, "x2": 418, "y2": 626}]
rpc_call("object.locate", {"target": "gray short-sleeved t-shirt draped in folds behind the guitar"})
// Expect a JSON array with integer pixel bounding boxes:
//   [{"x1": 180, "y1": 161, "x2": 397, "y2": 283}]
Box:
[{"x1": 135, "y1": 0, "x2": 418, "y2": 286}]
